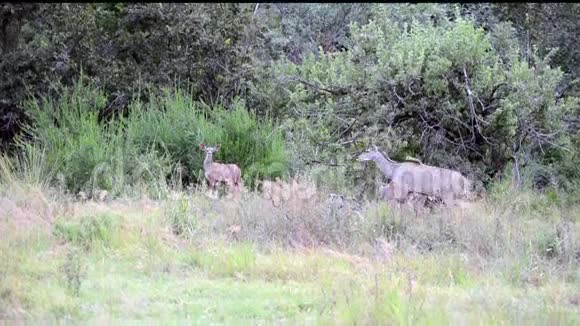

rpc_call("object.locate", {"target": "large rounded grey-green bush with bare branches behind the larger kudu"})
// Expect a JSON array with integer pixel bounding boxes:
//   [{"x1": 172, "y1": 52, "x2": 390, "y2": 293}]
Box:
[{"x1": 264, "y1": 12, "x2": 578, "y2": 191}]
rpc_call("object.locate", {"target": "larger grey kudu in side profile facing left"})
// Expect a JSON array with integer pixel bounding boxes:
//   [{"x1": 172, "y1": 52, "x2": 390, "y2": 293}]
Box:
[{"x1": 358, "y1": 146, "x2": 471, "y2": 205}]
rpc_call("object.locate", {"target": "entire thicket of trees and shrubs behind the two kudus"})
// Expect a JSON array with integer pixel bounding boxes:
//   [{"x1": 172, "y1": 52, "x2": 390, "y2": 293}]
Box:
[{"x1": 0, "y1": 3, "x2": 580, "y2": 200}]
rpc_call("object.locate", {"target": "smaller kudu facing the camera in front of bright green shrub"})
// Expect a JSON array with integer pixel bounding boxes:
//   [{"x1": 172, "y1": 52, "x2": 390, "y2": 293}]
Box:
[{"x1": 200, "y1": 144, "x2": 242, "y2": 198}]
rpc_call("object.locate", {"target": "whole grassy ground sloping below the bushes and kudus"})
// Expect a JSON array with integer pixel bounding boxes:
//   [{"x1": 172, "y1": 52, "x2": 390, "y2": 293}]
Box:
[{"x1": 0, "y1": 188, "x2": 580, "y2": 325}]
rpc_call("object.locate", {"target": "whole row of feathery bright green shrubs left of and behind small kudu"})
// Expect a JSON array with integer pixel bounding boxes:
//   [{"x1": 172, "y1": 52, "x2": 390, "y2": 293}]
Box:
[{"x1": 19, "y1": 80, "x2": 287, "y2": 198}]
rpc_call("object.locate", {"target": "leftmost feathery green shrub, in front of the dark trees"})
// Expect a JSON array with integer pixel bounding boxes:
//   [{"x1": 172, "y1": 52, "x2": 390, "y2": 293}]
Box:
[{"x1": 23, "y1": 80, "x2": 115, "y2": 193}]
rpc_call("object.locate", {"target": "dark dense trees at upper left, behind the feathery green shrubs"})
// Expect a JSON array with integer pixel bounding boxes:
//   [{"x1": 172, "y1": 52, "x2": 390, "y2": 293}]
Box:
[{"x1": 0, "y1": 3, "x2": 262, "y2": 153}]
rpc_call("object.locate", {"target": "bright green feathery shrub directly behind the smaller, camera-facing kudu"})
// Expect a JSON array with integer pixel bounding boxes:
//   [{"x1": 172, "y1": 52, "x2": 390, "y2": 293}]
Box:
[{"x1": 127, "y1": 89, "x2": 288, "y2": 186}]
